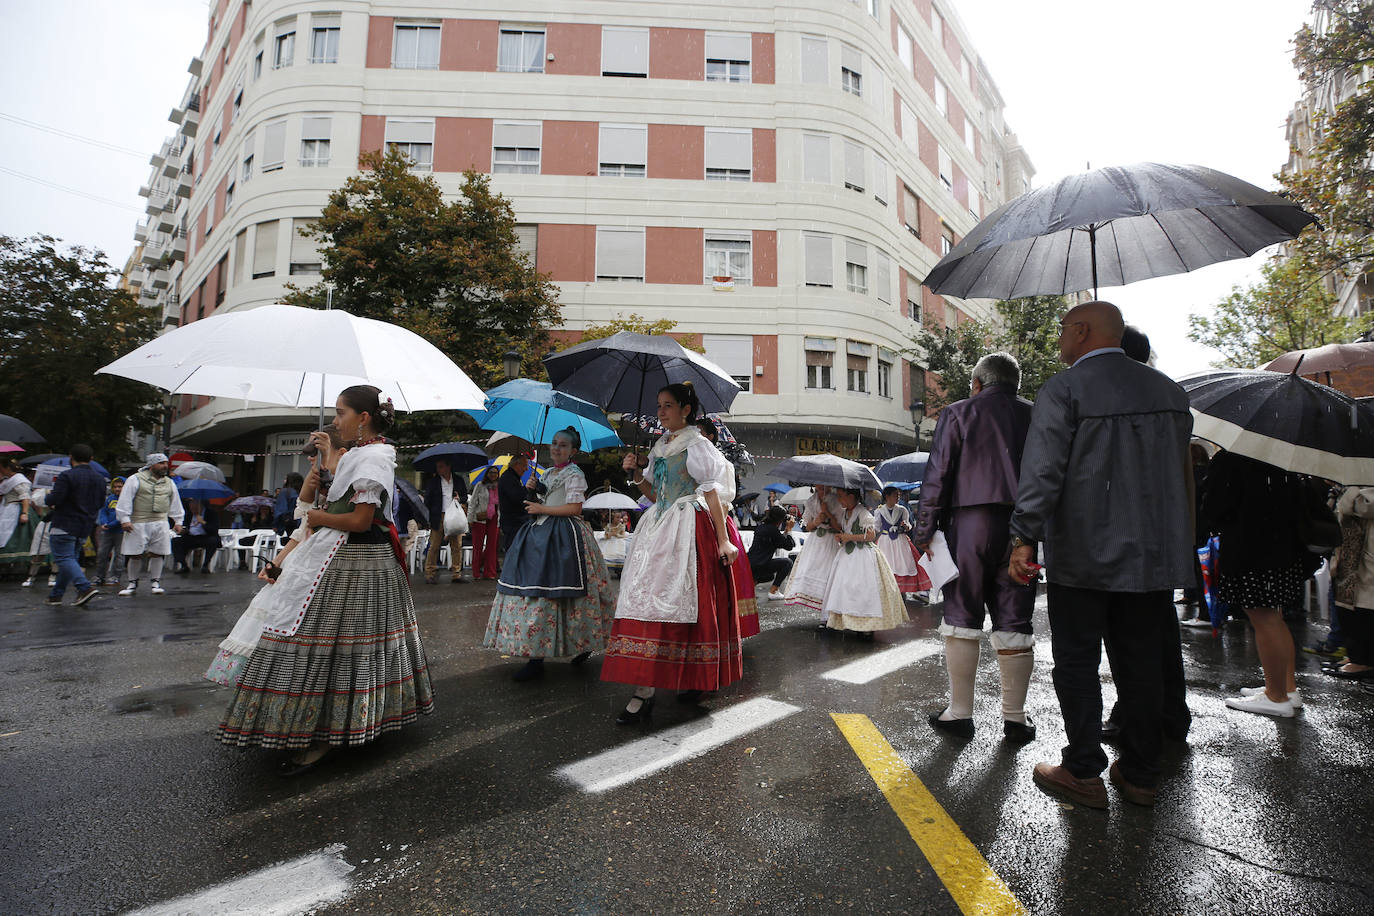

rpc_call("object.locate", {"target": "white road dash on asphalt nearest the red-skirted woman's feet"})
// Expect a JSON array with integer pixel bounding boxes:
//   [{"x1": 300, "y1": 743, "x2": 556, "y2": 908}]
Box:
[{"x1": 555, "y1": 694, "x2": 801, "y2": 792}]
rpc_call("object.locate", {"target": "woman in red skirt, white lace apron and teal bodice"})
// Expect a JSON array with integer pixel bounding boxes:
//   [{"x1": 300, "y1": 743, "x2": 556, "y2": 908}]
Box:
[{"x1": 602, "y1": 383, "x2": 753, "y2": 725}]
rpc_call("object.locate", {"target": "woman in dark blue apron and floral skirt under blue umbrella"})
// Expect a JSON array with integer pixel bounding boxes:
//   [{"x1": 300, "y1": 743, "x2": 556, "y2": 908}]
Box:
[{"x1": 482, "y1": 427, "x2": 616, "y2": 681}]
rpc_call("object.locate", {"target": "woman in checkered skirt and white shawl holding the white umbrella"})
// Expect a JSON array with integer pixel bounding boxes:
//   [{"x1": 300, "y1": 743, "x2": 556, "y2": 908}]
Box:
[{"x1": 218, "y1": 385, "x2": 434, "y2": 776}]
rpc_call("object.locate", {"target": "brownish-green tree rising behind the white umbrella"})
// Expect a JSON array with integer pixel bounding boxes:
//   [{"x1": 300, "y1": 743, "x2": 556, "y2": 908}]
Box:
[{"x1": 283, "y1": 147, "x2": 563, "y2": 438}]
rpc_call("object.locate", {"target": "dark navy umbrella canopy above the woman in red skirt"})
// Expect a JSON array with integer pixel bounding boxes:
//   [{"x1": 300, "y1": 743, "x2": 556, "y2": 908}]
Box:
[{"x1": 544, "y1": 331, "x2": 739, "y2": 413}]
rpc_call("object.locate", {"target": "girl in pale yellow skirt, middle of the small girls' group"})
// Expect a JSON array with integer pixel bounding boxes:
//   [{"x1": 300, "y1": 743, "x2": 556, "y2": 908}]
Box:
[{"x1": 822, "y1": 490, "x2": 910, "y2": 639}]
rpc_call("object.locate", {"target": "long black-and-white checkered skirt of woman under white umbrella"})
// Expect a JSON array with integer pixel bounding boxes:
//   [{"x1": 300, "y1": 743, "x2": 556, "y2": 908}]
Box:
[{"x1": 218, "y1": 544, "x2": 434, "y2": 748}]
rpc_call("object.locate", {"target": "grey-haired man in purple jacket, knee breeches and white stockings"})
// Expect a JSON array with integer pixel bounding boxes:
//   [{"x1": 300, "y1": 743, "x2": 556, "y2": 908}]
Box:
[{"x1": 911, "y1": 353, "x2": 1035, "y2": 742}]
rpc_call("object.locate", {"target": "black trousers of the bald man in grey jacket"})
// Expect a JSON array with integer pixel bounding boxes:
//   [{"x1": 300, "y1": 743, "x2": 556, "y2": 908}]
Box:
[{"x1": 1048, "y1": 582, "x2": 1178, "y2": 788}]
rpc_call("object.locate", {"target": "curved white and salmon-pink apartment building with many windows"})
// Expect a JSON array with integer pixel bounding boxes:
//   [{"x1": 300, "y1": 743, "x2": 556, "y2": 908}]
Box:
[{"x1": 135, "y1": 0, "x2": 1032, "y2": 472}]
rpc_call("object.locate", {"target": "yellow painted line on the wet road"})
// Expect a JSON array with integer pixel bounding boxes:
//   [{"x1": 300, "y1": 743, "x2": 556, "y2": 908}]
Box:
[{"x1": 830, "y1": 713, "x2": 1026, "y2": 916}]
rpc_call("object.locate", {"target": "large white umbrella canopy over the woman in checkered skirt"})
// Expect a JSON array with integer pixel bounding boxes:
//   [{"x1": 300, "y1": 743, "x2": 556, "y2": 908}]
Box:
[{"x1": 96, "y1": 305, "x2": 482, "y2": 411}]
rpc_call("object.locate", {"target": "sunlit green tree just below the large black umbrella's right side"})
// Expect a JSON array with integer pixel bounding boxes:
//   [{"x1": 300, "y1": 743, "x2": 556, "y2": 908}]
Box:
[{"x1": 1189, "y1": 255, "x2": 1370, "y2": 368}]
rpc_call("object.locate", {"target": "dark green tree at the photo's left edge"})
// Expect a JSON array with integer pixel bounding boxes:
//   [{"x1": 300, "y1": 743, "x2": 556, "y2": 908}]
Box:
[{"x1": 0, "y1": 235, "x2": 162, "y2": 461}]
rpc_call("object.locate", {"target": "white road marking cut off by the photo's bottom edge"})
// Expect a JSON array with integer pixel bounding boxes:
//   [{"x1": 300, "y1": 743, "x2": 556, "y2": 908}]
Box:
[{"x1": 129, "y1": 843, "x2": 353, "y2": 916}]
